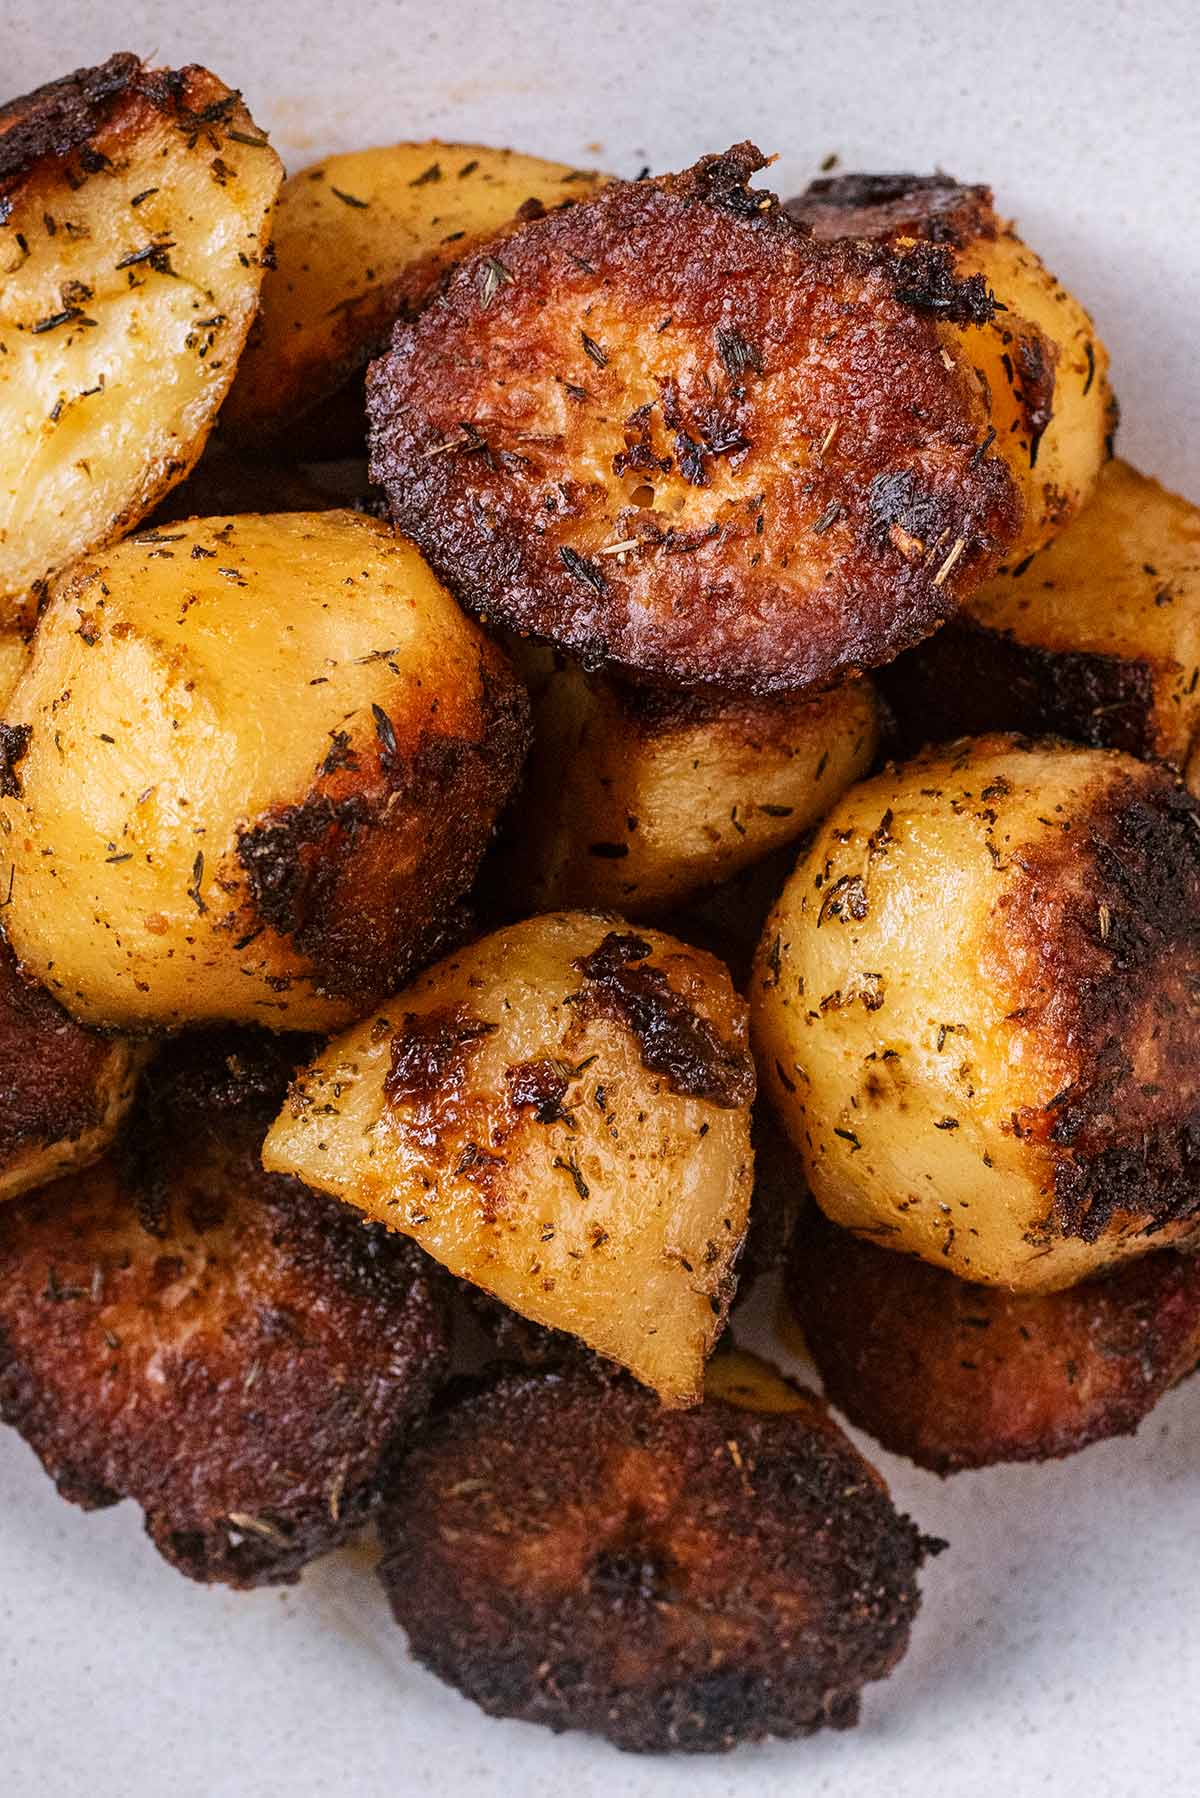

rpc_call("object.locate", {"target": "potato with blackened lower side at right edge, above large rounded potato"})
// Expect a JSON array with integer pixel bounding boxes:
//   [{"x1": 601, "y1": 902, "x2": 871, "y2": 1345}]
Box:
[{"x1": 883, "y1": 460, "x2": 1200, "y2": 773}]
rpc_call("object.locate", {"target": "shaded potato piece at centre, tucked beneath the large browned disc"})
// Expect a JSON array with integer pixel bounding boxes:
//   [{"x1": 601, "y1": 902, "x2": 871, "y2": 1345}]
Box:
[{"x1": 500, "y1": 649, "x2": 880, "y2": 917}]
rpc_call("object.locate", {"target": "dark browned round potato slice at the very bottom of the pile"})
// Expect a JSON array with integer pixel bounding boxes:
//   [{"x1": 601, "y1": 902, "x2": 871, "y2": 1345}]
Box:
[{"x1": 381, "y1": 1372, "x2": 925, "y2": 1753}]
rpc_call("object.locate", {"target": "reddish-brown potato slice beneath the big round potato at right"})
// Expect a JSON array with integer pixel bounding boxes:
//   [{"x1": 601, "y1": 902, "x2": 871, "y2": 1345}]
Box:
[{"x1": 786, "y1": 1206, "x2": 1200, "y2": 1474}]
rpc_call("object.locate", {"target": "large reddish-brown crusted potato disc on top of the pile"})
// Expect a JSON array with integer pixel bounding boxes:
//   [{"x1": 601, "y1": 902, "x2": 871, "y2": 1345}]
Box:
[{"x1": 367, "y1": 144, "x2": 1022, "y2": 692}]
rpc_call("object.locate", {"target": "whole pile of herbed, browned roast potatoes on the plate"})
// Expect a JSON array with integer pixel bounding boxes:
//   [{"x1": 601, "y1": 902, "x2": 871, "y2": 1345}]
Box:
[{"x1": 0, "y1": 56, "x2": 1200, "y2": 1749}]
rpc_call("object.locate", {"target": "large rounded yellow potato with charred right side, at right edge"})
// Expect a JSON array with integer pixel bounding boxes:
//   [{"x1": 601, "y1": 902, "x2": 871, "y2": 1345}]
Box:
[{"x1": 752, "y1": 737, "x2": 1200, "y2": 1291}]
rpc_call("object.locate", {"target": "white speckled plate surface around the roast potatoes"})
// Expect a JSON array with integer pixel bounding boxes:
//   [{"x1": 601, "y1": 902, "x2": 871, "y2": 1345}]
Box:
[{"x1": 0, "y1": 0, "x2": 1200, "y2": 1798}]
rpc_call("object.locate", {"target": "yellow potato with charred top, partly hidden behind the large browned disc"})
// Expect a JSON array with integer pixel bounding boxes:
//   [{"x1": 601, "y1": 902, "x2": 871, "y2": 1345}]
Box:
[{"x1": 788, "y1": 174, "x2": 1117, "y2": 565}]
